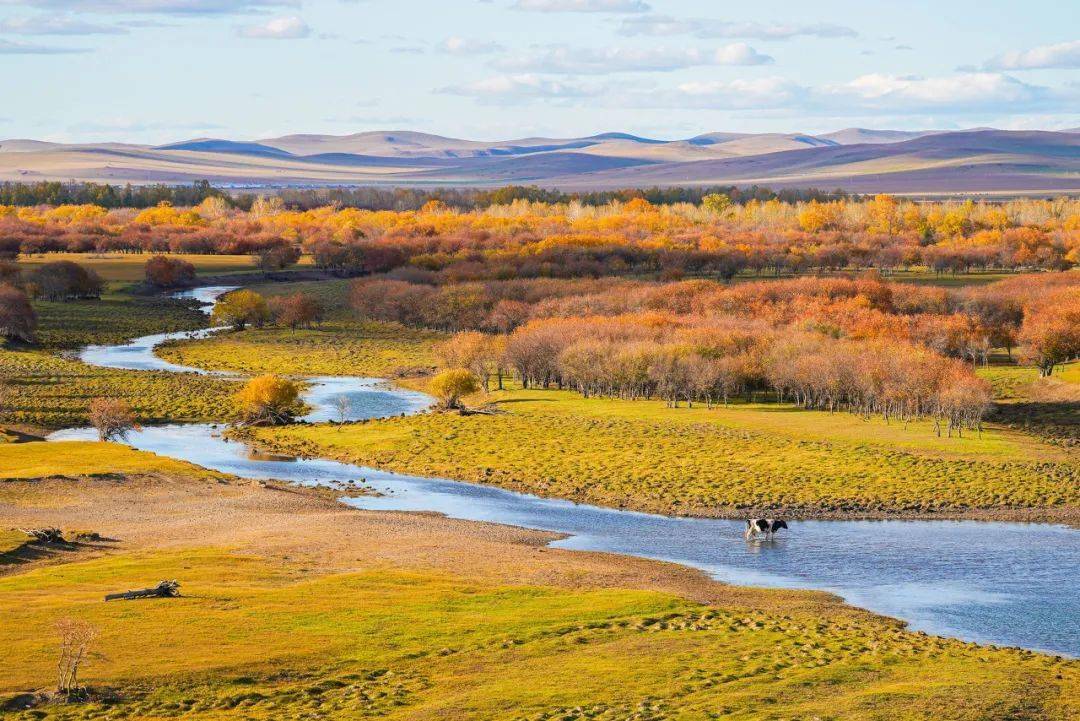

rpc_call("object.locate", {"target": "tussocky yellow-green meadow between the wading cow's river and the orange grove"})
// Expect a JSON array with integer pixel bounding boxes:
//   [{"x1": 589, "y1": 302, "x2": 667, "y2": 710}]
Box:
[{"x1": 245, "y1": 390, "x2": 1080, "y2": 515}]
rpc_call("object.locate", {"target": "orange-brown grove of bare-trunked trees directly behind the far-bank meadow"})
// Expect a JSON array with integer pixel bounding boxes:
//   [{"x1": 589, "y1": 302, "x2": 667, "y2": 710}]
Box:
[{"x1": 352, "y1": 274, "x2": 1080, "y2": 434}]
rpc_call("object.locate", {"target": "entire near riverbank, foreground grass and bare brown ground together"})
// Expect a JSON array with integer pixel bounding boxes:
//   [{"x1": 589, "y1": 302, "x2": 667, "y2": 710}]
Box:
[{"x1": 0, "y1": 444, "x2": 1080, "y2": 721}]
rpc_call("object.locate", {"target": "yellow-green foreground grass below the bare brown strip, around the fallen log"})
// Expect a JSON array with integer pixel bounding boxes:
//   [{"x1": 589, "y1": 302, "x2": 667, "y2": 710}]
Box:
[{"x1": 0, "y1": 548, "x2": 1078, "y2": 721}]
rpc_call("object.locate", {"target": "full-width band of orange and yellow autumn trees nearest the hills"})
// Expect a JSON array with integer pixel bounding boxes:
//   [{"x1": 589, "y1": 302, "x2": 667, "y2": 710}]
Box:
[{"x1": 0, "y1": 193, "x2": 1080, "y2": 274}]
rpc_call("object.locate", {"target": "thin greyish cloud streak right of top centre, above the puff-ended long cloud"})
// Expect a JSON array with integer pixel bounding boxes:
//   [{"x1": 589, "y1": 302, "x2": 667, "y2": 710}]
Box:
[{"x1": 619, "y1": 15, "x2": 859, "y2": 40}]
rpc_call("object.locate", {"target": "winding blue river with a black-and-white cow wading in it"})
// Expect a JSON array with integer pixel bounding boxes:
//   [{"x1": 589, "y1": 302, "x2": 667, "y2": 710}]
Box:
[{"x1": 50, "y1": 287, "x2": 1080, "y2": 656}]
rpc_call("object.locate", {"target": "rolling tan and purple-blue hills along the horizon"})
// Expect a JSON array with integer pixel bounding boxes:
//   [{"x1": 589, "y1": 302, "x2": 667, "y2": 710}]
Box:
[{"x1": 0, "y1": 127, "x2": 1080, "y2": 193}]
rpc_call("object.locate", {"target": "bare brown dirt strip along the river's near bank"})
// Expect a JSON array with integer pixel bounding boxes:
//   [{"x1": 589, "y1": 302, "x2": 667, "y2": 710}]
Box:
[{"x1": 0, "y1": 476, "x2": 840, "y2": 610}]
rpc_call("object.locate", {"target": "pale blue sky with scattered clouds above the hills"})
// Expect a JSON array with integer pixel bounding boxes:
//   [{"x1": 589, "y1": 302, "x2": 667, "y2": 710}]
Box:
[{"x1": 0, "y1": 0, "x2": 1080, "y2": 144}]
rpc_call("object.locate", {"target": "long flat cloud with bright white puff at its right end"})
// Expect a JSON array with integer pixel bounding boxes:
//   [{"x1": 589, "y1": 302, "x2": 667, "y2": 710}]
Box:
[{"x1": 491, "y1": 43, "x2": 772, "y2": 74}]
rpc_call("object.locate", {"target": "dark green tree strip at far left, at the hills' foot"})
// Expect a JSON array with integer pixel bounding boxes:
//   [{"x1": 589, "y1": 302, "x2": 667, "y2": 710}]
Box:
[{"x1": 0, "y1": 180, "x2": 228, "y2": 208}]
